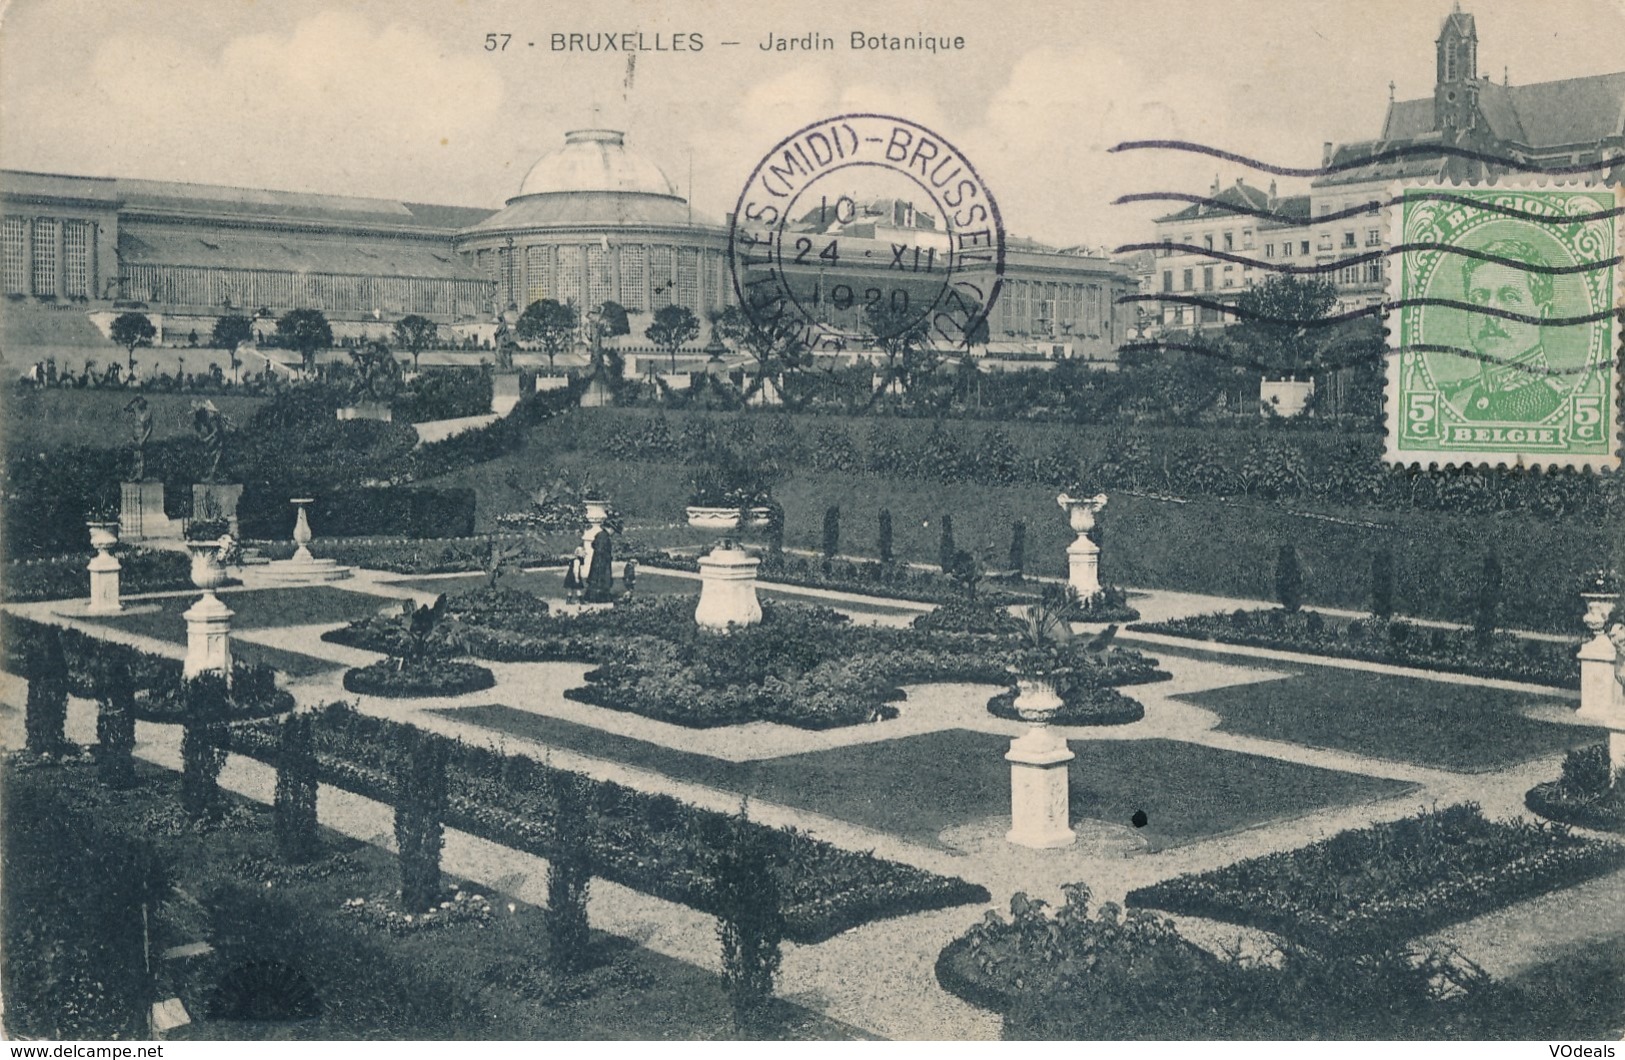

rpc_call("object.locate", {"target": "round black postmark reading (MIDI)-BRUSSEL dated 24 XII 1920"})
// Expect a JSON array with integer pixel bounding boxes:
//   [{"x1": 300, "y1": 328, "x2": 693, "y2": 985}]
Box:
[{"x1": 728, "y1": 114, "x2": 1004, "y2": 350}]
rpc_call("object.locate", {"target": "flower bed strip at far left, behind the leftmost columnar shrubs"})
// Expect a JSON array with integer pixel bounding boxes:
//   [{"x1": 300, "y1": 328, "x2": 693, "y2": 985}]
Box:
[{"x1": 0, "y1": 615, "x2": 294, "y2": 723}]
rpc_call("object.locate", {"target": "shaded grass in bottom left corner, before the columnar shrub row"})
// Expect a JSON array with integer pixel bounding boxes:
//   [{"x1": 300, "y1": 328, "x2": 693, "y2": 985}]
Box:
[{"x1": 5, "y1": 764, "x2": 856, "y2": 1040}]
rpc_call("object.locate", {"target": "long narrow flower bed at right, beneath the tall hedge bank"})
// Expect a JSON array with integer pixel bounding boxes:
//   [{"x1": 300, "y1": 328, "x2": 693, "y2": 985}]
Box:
[{"x1": 1134, "y1": 608, "x2": 1580, "y2": 688}]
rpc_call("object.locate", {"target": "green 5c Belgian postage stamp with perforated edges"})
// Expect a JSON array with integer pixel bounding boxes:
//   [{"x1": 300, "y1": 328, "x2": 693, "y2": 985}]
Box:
[{"x1": 1386, "y1": 185, "x2": 1625, "y2": 468}]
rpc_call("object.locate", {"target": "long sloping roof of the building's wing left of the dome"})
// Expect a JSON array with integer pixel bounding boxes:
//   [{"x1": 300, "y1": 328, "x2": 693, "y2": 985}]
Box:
[{"x1": 119, "y1": 224, "x2": 479, "y2": 280}]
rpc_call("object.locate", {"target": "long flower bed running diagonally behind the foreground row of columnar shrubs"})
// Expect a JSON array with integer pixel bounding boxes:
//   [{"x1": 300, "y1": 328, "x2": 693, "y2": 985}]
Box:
[{"x1": 231, "y1": 704, "x2": 988, "y2": 943}]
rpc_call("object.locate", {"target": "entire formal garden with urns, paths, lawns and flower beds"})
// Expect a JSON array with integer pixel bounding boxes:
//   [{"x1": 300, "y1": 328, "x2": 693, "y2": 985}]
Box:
[{"x1": 0, "y1": 348, "x2": 1625, "y2": 1039}]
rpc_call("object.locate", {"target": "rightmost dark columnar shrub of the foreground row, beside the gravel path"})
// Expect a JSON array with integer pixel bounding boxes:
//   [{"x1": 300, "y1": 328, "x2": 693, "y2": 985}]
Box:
[{"x1": 712, "y1": 816, "x2": 785, "y2": 1032}]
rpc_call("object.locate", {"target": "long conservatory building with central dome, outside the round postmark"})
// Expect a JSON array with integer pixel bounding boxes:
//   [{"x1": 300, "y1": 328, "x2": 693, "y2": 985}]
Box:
[{"x1": 0, "y1": 128, "x2": 1133, "y2": 363}]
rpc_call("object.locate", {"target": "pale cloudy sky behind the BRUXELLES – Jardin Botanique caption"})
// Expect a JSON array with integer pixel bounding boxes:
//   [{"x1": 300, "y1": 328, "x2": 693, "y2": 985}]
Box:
[{"x1": 0, "y1": 0, "x2": 1625, "y2": 247}]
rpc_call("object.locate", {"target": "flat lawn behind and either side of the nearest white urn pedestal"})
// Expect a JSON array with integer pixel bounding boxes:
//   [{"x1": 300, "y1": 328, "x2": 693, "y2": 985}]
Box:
[{"x1": 437, "y1": 706, "x2": 1412, "y2": 850}]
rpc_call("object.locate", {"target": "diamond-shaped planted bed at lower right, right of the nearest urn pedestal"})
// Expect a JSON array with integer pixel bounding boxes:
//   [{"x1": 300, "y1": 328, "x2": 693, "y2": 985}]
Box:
[{"x1": 1128, "y1": 803, "x2": 1625, "y2": 946}]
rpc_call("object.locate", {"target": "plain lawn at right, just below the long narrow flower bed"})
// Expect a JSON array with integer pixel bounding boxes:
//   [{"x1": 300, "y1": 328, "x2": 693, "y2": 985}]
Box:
[{"x1": 1157, "y1": 645, "x2": 1597, "y2": 772}]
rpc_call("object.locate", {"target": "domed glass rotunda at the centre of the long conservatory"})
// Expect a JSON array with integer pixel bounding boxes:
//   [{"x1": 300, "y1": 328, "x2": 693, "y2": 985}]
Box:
[{"x1": 455, "y1": 128, "x2": 733, "y2": 335}]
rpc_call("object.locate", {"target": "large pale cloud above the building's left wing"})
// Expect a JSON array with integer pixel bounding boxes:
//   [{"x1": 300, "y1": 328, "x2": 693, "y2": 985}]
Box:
[{"x1": 42, "y1": 11, "x2": 504, "y2": 197}]
